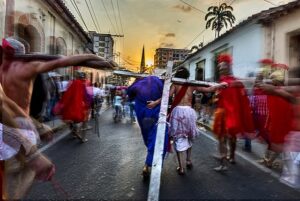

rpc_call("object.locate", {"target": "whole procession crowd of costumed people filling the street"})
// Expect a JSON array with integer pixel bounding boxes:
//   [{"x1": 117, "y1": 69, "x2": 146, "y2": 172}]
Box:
[{"x1": 0, "y1": 38, "x2": 300, "y2": 199}]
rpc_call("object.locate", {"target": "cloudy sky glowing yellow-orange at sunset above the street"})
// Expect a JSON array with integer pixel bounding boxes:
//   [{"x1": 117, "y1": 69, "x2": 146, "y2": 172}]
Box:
[{"x1": 64, "y1": 0, "x2": 292, "y2": 70}]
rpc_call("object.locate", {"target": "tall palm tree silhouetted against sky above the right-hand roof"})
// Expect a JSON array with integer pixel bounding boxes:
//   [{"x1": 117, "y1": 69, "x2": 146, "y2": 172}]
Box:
[{"x1": 205, "y1": 3, "x2": 235, "y2": 38}]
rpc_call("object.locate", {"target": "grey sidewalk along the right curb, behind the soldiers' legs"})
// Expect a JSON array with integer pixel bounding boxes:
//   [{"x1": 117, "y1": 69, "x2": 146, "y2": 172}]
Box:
[{"x1": 197, "y1": 120, "x2": 282, "y2": 174}]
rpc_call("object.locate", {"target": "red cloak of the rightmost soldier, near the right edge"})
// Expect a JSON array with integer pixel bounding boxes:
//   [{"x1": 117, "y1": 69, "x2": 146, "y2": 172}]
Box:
[{"x1": 267, "y1": 95, "x2": 293, "y2": 144}]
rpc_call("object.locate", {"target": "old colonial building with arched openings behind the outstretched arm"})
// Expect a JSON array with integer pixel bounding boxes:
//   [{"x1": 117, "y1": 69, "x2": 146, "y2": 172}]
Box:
[{"x1": 0, "y1": 0, "x2": 112, "y2": 85}]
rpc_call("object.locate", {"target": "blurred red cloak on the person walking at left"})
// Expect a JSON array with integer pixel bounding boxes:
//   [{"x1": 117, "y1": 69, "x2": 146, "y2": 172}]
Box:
[{"x1": 58, "y1": 80, "x2": 89, "y2": 122}]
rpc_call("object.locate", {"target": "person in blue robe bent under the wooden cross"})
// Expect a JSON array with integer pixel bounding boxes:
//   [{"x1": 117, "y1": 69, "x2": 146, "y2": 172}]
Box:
[{"x1": 127, "y1": 76, "x2": 168, "y2": 178}]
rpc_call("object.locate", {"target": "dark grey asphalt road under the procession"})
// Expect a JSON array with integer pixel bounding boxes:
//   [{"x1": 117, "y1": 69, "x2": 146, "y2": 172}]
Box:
[{"x1": 26, "y1": 110, "x2": 300, "y2": 200}]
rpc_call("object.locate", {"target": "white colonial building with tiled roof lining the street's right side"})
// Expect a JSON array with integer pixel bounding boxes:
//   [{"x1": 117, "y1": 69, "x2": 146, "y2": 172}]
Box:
[{"x1": 182, "y1": 1, "x2": 300, "y2": 80}]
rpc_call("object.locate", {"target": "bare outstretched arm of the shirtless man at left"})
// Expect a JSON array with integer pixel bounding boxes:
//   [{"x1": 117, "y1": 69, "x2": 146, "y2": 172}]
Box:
[{"x1": 33, "y1": 54, "x2": 104, "y2": 74}]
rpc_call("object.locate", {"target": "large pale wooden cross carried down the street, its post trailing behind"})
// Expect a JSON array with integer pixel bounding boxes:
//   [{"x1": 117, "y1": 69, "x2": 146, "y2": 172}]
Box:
[{"x1": 114, "y1": 61, "x2": 218, "y2": 201}]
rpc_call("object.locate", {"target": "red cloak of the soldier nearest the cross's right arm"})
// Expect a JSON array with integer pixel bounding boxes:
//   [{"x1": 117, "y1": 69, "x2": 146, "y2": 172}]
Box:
[{"x1": 218, "y1": 75, "x2": 254, "y2": 135}]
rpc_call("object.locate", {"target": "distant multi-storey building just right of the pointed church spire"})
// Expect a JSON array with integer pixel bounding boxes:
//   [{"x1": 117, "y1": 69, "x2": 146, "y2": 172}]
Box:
[{"x1": 154, "y1": 48, "x2": 190, "y2": 68}]
